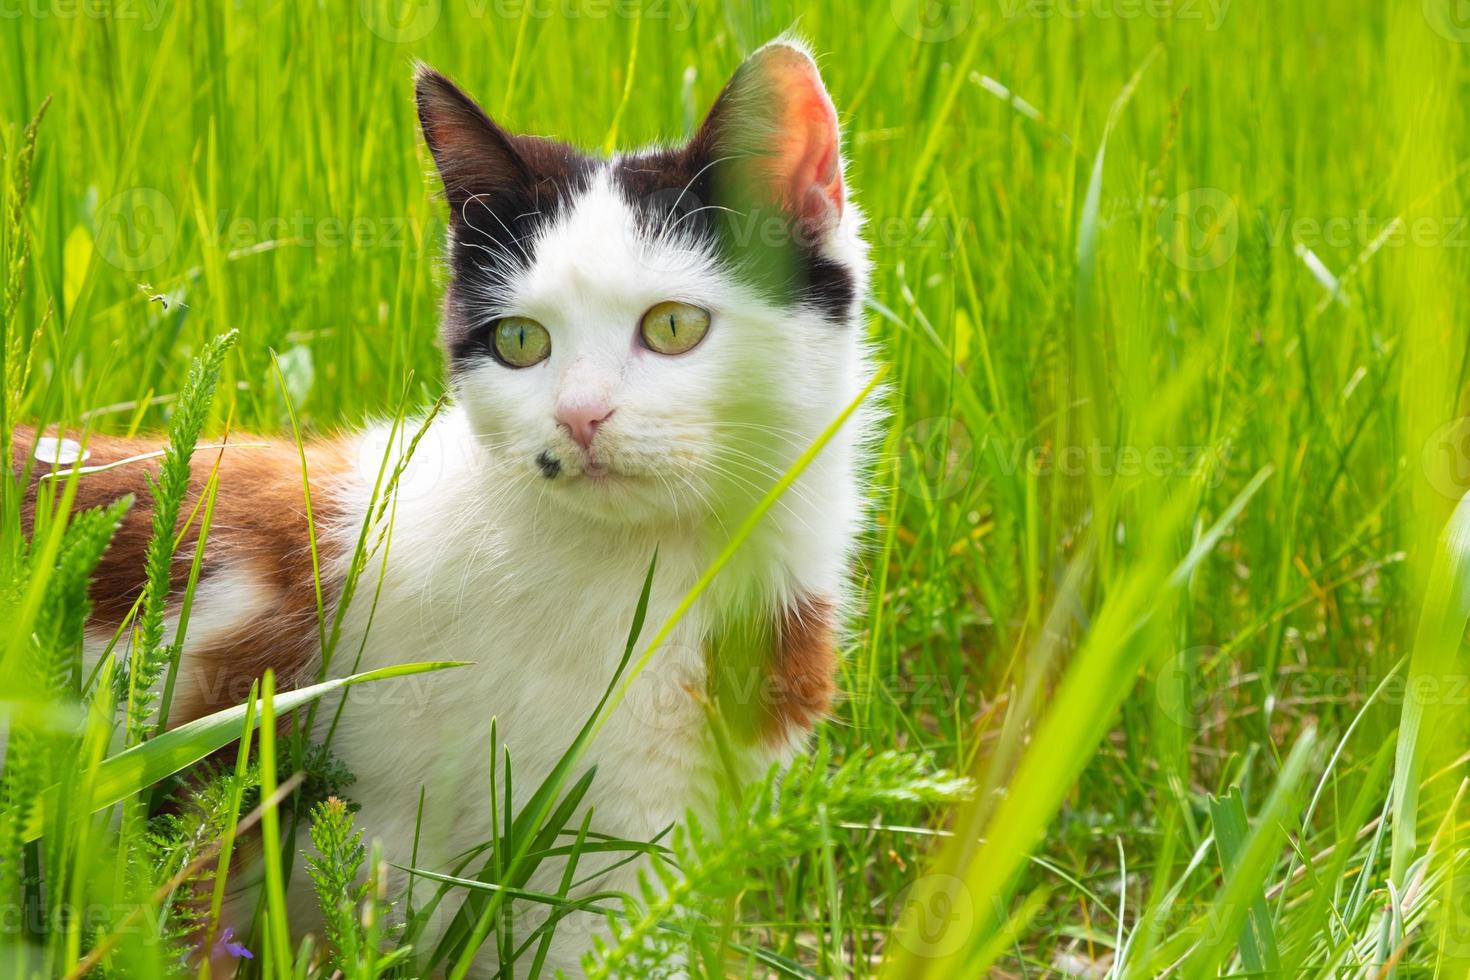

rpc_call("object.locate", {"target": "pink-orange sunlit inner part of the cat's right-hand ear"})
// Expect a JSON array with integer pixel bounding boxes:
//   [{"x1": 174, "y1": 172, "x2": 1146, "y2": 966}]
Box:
[{"x1": 766, "y1": 46, "x2": 842, "y2": 231}]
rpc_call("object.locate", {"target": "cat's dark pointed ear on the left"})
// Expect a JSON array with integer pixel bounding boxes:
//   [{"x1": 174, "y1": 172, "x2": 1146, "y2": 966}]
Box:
[{"x1": 415, "y1": 63, "x2": 531, "y2": 222}]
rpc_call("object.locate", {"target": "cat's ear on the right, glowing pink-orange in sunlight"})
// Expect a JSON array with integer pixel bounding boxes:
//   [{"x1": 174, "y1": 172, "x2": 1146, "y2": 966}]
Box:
[{"x1": 692, "y1": 40, "x2": 845, "y2": 238}]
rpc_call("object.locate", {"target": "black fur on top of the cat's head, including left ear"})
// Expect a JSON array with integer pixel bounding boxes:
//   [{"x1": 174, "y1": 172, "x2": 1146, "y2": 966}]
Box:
[{"x1": 416, "y1": 53, "x2": 858, "y2": 376}]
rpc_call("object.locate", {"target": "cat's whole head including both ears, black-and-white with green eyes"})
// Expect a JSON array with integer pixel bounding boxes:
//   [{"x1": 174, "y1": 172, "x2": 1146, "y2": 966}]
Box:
[{"x1": 419, "y1": 46, "x2": 866, "y2": 523}]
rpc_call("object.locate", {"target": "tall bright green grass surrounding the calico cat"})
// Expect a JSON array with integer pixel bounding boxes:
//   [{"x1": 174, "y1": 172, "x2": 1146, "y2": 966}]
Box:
[{"x1": 0, "y1": 0, "x2": 1470, "y2": 979}]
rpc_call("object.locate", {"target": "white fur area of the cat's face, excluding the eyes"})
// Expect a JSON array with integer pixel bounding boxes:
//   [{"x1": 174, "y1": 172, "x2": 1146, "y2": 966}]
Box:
[{"x1": 456, "y1": 172, "x2": 858, "y2": 522}]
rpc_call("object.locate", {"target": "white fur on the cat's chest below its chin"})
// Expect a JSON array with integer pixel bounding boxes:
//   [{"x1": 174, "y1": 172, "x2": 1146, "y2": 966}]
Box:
[{"x1": 286, "y1": 411, "x2": 857, "y2": 963}]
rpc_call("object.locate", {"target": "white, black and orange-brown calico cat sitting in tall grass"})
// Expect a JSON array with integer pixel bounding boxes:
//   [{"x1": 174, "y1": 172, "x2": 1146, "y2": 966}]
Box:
[{"x1": 13, "y1": 38, "x2": 879, "y2": 973}]
